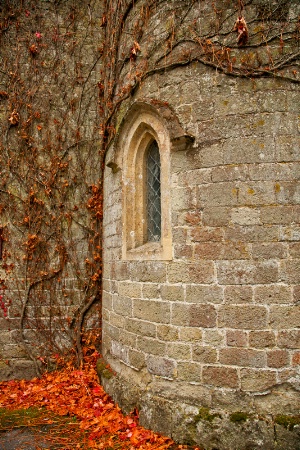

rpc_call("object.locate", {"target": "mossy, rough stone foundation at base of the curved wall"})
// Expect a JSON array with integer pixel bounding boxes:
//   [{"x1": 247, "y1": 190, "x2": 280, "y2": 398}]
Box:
[{"x1": 98, "y1": 362, "x2": 300, "y2": 450}]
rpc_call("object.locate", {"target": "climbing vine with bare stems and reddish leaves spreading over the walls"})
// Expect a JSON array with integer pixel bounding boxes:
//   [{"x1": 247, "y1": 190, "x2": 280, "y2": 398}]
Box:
[{"x1": 0, "y1": 0, "x2": 300, "y2": 371}]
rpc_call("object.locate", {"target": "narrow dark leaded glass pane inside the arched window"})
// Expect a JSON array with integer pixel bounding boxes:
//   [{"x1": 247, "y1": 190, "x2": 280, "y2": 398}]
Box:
[{"x1": 146, "y1": 141, "x2": 161, "y2": 242}]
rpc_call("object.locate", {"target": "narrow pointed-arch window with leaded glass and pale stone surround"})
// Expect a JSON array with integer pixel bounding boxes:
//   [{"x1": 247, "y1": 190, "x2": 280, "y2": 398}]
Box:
[{"x1": 119, "y1": 106, "x2": 172, "y2": 260}]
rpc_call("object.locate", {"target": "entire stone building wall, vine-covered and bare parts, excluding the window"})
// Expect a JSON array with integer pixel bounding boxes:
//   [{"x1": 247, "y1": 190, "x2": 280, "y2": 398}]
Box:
[{"x1": 0, "y1": 0, "x2": 300, "y2": 449}]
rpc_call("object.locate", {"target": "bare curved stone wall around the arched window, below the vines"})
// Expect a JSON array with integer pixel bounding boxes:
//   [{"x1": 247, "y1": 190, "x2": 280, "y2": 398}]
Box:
[{"x1": 101, "y1": 0, "x2": 300, "y2": 449}]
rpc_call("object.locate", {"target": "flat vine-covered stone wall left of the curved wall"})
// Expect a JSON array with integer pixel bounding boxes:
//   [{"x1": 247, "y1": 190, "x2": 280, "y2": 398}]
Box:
[{"x1": 0, "y1": 0, "x2": 103, "y2": 379}]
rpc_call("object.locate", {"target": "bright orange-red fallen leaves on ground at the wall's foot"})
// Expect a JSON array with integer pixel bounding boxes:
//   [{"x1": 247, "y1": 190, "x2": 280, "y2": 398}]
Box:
[{"x1": 0, "y1": 350, "x2": 197, "y2": 450}]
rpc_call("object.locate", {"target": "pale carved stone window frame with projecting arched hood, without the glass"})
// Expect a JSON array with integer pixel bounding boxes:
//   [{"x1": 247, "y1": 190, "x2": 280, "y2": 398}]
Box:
[{"x1": 106, "y1": 100, "x2": 194, "y2": 261}]
